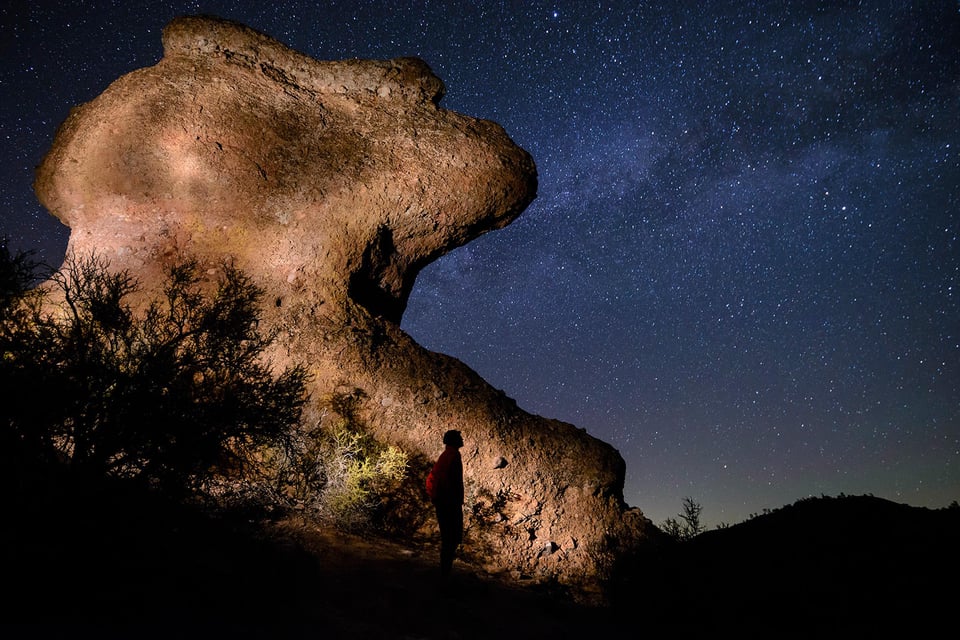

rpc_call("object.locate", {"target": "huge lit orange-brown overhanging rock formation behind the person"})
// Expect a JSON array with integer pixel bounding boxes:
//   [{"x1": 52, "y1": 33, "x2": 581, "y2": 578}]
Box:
[{"x1": 35, "y1": 17, "x2": 649, "y2": 584}]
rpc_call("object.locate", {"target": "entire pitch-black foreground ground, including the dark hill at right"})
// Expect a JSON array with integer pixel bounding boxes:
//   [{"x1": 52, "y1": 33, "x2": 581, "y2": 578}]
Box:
[{"x1": 0, "y1": 482, "x2": 960, "y2": 640}]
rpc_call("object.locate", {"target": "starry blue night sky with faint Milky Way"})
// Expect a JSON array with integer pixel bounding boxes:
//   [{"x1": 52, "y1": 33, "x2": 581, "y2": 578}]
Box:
[{"x1": 0, "y1": 0, "x2": 960, "y2": 526}]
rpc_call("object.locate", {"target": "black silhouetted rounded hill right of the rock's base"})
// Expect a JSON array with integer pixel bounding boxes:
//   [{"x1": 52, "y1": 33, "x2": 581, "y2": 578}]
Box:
[{"x1": 617, "y1": 496, "x2": 960, "y2": 637}]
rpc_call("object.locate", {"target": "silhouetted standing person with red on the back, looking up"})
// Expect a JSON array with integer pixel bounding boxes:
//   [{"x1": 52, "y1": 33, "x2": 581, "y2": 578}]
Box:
[{"x1": 427, "y1": 430, "x2": 463, "y2": 578}]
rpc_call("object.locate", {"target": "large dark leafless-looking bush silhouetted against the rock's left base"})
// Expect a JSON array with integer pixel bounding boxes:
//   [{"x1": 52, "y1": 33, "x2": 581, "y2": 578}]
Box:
[{"x1": 0, "y1": 246, "x2": 306, "y2": 495}]
